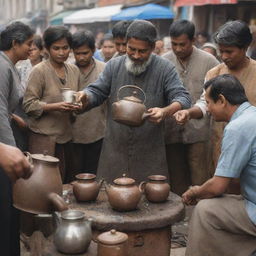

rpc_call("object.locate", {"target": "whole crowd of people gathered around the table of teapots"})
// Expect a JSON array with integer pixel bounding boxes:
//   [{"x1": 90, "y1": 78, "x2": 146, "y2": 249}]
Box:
[{"x1": 0, "y1": 17, "x2": 256, "y2": 256}]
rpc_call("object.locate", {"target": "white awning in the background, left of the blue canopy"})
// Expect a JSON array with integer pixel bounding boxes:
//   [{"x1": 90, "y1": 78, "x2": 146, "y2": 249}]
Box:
[{"x1": 63, "y1": 4, "x2": 122, "y2": 24}]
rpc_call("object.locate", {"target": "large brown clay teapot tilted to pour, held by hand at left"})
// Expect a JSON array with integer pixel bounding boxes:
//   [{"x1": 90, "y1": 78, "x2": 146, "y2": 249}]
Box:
[{"x1": 13, "y1": 152, "x2": 68, "y2": 214}]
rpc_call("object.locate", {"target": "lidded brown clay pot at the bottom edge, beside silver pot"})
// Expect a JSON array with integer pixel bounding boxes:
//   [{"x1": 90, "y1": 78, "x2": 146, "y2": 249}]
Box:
[{"x1": 97, "y1": 229, "x2": 128, "y2": 256}]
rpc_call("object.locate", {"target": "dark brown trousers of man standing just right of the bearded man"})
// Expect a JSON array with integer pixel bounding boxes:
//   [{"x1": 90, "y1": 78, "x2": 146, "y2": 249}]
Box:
[{"x1": 166, "y1": 142, "x2": 212, "y2": 195}]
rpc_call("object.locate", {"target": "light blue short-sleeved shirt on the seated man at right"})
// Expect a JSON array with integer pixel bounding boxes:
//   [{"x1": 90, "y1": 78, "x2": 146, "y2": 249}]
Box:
[{"x1": 215, "y1": 102, "x2": 256, "y2": 224}]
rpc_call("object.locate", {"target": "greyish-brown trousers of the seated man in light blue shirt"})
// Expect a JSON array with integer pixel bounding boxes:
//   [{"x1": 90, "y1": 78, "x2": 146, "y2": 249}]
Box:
[{"x1": 186, "y1": 195, "x2": 256, "y2": 256}]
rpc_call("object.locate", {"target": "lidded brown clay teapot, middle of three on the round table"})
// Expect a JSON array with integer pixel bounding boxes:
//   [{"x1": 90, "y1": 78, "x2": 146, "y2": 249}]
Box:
[{"x1": 105, "y1": 174, "x2": 143, "y2": 212}]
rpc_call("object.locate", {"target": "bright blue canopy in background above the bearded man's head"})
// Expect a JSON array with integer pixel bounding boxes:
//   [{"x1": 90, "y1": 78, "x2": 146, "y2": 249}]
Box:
[{"x1": 111, "y1": 4, "x2": 174, "y2": 20}]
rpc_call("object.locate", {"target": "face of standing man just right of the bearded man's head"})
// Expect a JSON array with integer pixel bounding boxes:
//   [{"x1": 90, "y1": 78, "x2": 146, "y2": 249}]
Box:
[{"x1": 171, "y1": 34, "x2": 194, "y2": 60}]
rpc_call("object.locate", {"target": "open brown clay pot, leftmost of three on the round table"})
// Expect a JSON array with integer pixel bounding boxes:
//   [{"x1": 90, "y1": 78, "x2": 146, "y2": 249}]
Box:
[{"x1": 72, "y1": 173, "x2": 103, "y2": 202}]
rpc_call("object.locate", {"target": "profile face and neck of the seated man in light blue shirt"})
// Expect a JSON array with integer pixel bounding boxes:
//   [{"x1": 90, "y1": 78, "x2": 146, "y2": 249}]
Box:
[{"x1": 205, "y1": 86, "x2": 226, "y2": 122}]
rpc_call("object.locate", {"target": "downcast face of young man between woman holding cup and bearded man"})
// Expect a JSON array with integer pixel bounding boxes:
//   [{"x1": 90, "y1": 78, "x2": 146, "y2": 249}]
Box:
[{"x1": 73, "y1": 45, "x2": 94, "y2": 67}]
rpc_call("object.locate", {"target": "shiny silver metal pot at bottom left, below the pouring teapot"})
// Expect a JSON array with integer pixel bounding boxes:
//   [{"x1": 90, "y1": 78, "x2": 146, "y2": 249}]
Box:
[{"x1": 53, "y1": 210, "x2": 92, "y2": 255}]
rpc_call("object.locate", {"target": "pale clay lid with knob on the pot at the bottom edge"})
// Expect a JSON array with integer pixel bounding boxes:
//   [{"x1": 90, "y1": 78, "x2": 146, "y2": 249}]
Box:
[{"x1": 97, "y1": 229, "x2": 128, "y2": 245}]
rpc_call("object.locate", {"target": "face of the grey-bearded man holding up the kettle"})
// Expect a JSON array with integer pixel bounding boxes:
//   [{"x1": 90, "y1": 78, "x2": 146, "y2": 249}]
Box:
[{"x1": 127, "y1": 38, "x2": 155, "y2": 65}]
